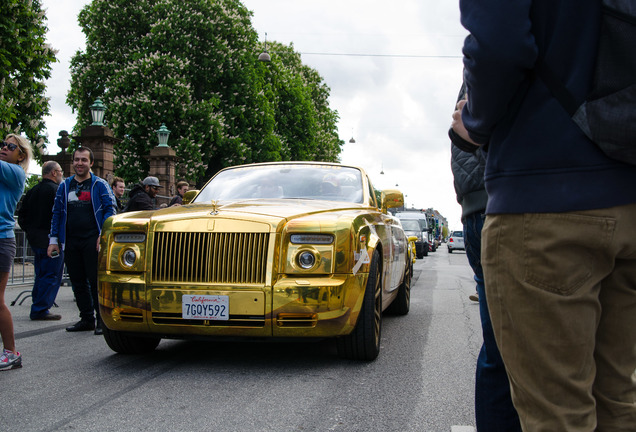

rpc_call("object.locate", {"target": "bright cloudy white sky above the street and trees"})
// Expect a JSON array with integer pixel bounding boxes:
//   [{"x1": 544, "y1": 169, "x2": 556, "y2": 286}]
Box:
[{"x1": 42, "y1": 0, "x2": 467, "y2": 229}]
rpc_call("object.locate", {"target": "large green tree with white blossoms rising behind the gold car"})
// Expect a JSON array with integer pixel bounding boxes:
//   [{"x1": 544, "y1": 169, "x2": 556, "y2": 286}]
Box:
[{"x1": 68, "y1": 0, "x2": 341, "y2": 184}]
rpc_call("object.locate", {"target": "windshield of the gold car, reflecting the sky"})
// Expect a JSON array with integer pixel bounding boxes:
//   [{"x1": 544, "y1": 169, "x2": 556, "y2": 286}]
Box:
[{"x1": 194, "y1": 164, "x2": 363, "y2": 203}]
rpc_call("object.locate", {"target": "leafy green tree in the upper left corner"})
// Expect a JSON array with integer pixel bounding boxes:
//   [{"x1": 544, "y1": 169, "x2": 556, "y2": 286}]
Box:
[{"x1": 0, "y1": 0, "x2": 56, "y2": 160}]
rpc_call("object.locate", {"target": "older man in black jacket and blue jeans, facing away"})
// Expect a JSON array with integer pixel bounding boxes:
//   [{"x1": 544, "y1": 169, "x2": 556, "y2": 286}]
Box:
[{"x1": 18, "y1": 161, "x2": 64, "y2": 321}]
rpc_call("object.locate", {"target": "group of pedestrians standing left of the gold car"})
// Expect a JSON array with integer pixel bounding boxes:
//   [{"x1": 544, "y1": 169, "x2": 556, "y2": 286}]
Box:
[{"x1": 0, "y1": 142, "x2": 188, "y2": 370}]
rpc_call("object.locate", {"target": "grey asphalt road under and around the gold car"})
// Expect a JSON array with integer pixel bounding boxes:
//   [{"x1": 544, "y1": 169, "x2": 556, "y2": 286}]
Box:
[{"x1": 0, "y1": 245, "x2": 481, "y2": 432}]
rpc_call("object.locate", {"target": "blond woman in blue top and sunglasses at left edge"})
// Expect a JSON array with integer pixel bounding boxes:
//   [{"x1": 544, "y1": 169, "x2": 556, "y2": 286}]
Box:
[{"x1": 0, "y1": 134, "x2": 31, "y2": 371}]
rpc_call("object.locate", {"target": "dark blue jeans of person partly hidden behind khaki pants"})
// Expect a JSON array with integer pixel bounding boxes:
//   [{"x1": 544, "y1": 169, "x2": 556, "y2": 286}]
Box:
[{"x1": 463, "y1": 212, "x2": 521, "y2": 432}]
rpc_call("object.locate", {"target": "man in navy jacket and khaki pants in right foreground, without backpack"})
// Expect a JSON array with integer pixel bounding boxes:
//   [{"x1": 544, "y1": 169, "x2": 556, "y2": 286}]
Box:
[{"x1": 453, "y1": 0, "x2": 636, "y2": 431}]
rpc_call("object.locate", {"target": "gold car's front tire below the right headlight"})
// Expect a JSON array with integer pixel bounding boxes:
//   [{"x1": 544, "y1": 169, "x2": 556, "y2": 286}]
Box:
[{"x1": 337, "y1": 250, "x2": 382, "y2": 361}]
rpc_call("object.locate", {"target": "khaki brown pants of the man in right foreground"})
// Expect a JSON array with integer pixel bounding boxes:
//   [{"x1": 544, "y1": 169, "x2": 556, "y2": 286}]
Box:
[{"x1": 482, "y1": 204, "x2": 636, "y2": 432}]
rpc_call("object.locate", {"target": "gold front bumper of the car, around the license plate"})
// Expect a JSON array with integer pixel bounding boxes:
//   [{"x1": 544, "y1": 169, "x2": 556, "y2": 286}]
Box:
[{"x1": 99, "y1": 272, "x2": 368, "y2": 339}]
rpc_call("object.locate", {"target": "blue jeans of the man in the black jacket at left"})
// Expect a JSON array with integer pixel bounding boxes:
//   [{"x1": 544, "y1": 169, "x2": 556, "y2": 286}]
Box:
[{"x1": 30, "y1": 247, "x2": 64, "y2": 319}]
